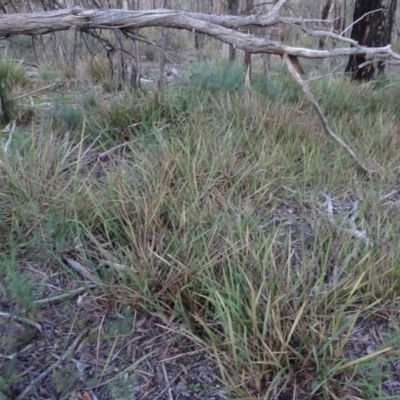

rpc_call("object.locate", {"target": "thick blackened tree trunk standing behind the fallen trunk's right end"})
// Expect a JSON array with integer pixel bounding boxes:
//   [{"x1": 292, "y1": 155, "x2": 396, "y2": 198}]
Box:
[{"x1": 346, "y1": 0, "x2": 397, "y2": 81}]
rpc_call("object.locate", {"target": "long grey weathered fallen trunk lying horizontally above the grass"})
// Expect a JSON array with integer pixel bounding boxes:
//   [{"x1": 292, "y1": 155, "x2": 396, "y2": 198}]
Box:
[{"x1": 0, "y1": 6, "x2": 400, "y2": 62}]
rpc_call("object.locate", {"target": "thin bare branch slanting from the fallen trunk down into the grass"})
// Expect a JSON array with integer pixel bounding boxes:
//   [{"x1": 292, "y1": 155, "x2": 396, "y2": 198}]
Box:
[{"x1": 283, "y1": 54, "x2": 375, "y2": 174}]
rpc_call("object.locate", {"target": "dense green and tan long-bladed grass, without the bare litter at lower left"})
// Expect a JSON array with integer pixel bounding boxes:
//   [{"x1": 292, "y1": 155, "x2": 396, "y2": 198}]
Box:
[{"x1": 0, "y1": 60, "x2": 400, "y2": 399}]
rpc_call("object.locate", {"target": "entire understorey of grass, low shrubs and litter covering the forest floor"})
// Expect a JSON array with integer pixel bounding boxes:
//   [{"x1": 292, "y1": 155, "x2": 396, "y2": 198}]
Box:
[{"x1": 0, "y1": 10, "x2": 400, "y2": 399}]
